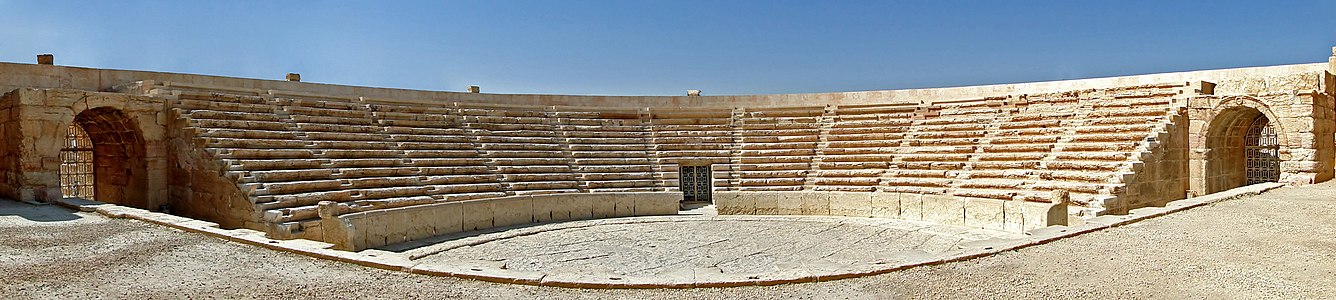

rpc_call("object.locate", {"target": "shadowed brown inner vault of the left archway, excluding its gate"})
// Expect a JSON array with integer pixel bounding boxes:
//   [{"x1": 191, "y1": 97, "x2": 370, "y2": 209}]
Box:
[{"x1": 73, "y1": 107, "x2": 152, "y2": 209}]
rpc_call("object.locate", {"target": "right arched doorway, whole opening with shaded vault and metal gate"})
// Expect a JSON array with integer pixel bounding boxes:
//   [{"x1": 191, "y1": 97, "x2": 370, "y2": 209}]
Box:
[{"x1": 1202, "y1": 105, "x2": 1284, "y2": 193}]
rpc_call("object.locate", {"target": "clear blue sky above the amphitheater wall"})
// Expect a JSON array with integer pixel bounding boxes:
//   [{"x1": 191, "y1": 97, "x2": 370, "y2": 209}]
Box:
[{"x1": 0, "y1": 0, "x2": 1336, "y2": 95}]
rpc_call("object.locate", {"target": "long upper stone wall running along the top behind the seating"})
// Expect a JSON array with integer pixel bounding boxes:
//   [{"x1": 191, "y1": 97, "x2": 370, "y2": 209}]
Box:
[{"x1": 0, "y1": 63, "x2": 1332, "y2": 108}]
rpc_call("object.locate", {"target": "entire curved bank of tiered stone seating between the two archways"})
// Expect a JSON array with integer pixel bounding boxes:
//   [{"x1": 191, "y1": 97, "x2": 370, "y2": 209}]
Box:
[{"x1": 164, "y1": 84, "x2": 1182, "y2": 237}]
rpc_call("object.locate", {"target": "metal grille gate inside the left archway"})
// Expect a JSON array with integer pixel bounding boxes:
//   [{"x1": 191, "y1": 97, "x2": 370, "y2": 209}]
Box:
[{"x1": 60, "y1": 124, "x2": 94, "y2": 200}]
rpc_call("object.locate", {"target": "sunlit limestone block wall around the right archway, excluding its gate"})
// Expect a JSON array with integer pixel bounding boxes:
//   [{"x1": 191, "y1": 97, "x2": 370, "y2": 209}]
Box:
[{"x1": 1188, "y1": 71, "x2": 1336, "y2": 195}]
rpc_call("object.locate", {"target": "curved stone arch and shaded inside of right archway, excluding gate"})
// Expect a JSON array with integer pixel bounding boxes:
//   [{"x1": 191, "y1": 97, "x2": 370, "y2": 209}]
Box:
[{"x1": 1201, "y1": 96, "x2": 1291, "y2": 193}]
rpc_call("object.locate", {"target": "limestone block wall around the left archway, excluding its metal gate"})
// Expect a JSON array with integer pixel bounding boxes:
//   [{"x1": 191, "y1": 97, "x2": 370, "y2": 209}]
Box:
[{"x1": 0, "y1": 88, "x2": 171, "y2": 208}]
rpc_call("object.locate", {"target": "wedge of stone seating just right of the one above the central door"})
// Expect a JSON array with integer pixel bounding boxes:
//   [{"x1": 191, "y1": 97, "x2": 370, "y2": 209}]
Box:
[{"x1": 733, "y1": 107, "x2": 826, "y2": 191}]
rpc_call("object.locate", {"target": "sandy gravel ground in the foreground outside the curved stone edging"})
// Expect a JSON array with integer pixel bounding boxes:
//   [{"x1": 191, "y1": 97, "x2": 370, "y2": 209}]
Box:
[{"x1": 0, "y1": 183, "x2": 1336, "y2": 299}]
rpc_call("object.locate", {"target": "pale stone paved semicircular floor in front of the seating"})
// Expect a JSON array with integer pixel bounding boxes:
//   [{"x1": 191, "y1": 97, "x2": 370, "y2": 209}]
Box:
[{"x1": 409, "y1": 215, "x2": 1021, "y2": 277}]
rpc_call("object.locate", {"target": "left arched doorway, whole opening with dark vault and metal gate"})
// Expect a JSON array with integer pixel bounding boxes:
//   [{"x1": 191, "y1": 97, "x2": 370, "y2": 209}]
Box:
[{"x1": 60, "y1": 107, "x2": 150, "y2": 209}]
